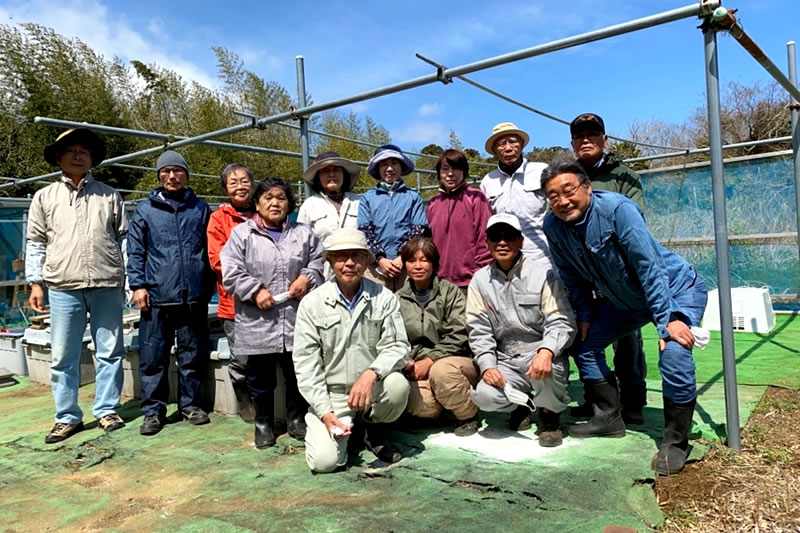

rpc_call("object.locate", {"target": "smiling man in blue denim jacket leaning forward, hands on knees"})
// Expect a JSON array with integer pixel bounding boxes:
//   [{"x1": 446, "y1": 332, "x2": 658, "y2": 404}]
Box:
[{"x1": 541, "y1": 161, "x2": 707, "y2": 475}]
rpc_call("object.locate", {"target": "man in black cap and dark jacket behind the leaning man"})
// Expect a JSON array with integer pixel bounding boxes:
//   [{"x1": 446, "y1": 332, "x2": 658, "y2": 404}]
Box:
[{"x1": 569, "y1": 113, "x2": 647, "y2": 424}]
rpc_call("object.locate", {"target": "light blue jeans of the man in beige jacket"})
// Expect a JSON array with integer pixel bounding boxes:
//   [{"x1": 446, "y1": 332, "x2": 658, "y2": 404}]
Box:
[{"x1": 50, "y1": 287, "x2": 125, "y2": 424}]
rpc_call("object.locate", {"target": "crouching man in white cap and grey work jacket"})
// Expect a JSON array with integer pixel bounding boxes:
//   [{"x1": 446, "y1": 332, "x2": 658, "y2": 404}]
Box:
[{"x1": 467, "y1": 213, "x2": 576, "y2": 447}]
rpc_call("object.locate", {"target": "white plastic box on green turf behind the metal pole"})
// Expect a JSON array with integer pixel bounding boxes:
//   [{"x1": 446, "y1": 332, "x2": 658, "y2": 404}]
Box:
[{"x1": 703, "y1": 287, "x2": 775, "y2": 333}]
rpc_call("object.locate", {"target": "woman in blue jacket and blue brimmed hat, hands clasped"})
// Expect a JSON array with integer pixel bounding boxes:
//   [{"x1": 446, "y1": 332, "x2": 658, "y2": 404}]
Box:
[{"x1": 358, "y1": 144, "x2": 428, "y2": 292}]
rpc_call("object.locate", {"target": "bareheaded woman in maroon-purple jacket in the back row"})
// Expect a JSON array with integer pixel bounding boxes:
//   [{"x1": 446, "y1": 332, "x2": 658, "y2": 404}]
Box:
[{"x1": 428, "y1": 150, "x2": 492, "y2": 290}]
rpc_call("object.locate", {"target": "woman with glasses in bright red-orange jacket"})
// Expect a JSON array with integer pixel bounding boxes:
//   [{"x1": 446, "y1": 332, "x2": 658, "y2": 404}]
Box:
[{"x1": 206, "y1": 163, "x2": 255, "y2": 422}]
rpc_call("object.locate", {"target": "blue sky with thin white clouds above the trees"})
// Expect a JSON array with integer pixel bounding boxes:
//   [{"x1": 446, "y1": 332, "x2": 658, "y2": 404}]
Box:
[{"x1": 0, "y1": 0, "x2": 800, "y2": 156}]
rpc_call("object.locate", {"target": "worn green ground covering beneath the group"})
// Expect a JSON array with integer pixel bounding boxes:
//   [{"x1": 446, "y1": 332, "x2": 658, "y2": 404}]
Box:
[{"x1": 0, "y1": 317, "x2": 800, "y2": 532}]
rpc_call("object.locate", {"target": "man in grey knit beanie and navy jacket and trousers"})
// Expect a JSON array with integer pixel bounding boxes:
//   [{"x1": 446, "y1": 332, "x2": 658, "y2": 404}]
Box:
[{"x1": 128, "y1": 151, "x2": 215, "y2": 435}]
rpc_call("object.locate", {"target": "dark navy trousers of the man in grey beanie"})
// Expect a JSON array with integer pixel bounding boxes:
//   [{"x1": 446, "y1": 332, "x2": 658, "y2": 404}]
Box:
[{"x1": 139, "y1": 303, "x2": 209, "y2": 417}]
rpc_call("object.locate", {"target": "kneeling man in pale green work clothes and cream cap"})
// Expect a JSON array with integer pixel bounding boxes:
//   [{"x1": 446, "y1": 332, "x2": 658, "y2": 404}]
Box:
[{"x1": 293, "y1": 228, "x2": 411, "y2": 473}]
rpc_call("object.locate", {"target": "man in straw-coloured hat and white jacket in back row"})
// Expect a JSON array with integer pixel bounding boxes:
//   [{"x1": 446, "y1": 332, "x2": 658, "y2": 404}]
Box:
[{"x1": 481, "y1": 122, "x2": 550, "y2": 267}]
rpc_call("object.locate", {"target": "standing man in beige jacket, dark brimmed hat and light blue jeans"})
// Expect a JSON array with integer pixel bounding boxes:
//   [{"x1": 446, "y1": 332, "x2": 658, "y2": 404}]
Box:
[{"x1": 25, "y1": 128, "x2": 128, "y2": 443}]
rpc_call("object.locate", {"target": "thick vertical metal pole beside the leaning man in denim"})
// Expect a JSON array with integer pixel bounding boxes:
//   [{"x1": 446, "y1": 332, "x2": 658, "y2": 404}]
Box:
[{"x1": 703, "y1": 25, "x2": 742, "y2": 451}]
